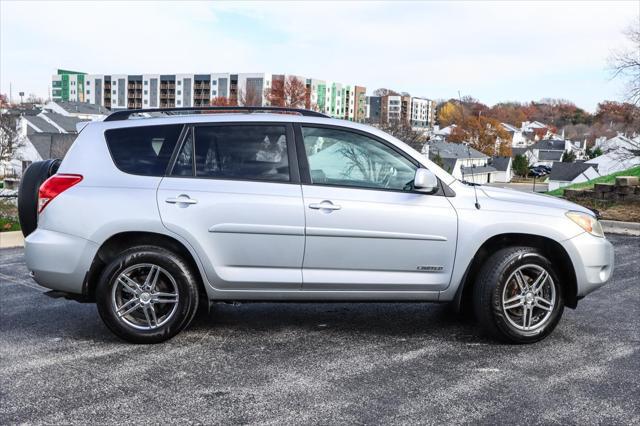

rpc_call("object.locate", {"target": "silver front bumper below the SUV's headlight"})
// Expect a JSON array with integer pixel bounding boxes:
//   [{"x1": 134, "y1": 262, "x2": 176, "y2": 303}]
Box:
[{"x1": 562, "y1": 232, "x2": 614, "y2": 298}]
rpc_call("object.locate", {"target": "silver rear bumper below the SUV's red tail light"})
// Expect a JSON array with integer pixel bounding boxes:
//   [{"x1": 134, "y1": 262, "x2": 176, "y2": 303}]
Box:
[{"x1": 24, "y1": 228, "x2": 99, "y2": 294}]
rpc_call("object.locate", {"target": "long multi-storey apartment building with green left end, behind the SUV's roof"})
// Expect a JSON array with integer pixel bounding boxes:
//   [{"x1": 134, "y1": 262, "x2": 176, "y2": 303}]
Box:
[{"x1": 51, "y1": 70, "x2": 366, "y2": 121}]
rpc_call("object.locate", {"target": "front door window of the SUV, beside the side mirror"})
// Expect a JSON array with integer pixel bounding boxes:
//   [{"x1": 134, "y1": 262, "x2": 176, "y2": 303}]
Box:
[{"x1": 302, "y1": 127, "x2": 417, "y2": 191}]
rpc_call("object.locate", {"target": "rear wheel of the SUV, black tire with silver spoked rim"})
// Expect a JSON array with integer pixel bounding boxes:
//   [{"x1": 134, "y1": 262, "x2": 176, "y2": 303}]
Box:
[{"x1": 96, "y1": 246, "x2": 199, "y2": 343}]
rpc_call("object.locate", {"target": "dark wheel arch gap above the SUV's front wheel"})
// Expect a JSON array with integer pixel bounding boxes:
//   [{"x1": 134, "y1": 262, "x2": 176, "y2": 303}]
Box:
[{"x1": 453, "y1": 233, "x2": 578, "y2": 312}]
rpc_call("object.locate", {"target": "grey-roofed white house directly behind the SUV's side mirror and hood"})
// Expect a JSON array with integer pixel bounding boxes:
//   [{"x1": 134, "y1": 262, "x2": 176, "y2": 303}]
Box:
[{"x1": 422, "y1": 141, "x2": 496, "y2": 183}]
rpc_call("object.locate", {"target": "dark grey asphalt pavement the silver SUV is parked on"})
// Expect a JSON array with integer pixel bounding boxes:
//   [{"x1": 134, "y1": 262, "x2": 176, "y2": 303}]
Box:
[{"x1": 0, "y1": 236, "x2": 640, "y2": 425}]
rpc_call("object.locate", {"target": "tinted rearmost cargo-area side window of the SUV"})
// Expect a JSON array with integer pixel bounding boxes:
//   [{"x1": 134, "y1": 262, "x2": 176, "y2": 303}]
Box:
[{"x1": 105, "y1": 125, "x2": 182, "y2": 176}]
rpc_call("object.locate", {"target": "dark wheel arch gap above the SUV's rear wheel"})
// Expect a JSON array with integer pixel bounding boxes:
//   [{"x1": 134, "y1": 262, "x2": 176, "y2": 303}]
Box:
[{"x1": 82, "y1": 231, "x2": 206, "y2": 301}]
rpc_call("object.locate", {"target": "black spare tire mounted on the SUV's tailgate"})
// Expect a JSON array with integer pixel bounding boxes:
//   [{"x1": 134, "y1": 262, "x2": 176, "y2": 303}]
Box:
[{"x1": 18, "y1": 160, "x2": 61, "y2": 237}]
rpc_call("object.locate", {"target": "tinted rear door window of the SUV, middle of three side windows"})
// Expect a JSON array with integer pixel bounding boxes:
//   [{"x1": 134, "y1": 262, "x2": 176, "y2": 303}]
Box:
[{"x1": 172, "y1": 125, "x2": 289, "y2": 182}]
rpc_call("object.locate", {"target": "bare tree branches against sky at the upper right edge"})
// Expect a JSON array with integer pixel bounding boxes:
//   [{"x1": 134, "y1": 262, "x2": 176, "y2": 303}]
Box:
[{"x1": 609, "y1": 23, "x2": 640, "y2": 105}]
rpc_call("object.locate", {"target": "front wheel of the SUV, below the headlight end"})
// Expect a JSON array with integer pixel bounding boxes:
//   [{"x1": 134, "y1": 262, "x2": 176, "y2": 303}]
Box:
[{"x1": 473, "y1": 247, "x2": 564, "y2": 343}]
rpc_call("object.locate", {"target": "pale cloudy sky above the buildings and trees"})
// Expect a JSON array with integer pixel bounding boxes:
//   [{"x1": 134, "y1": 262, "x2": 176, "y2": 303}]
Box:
[{"x1": 0, "y1": 0, "x2": 640, "y2": 112}]
